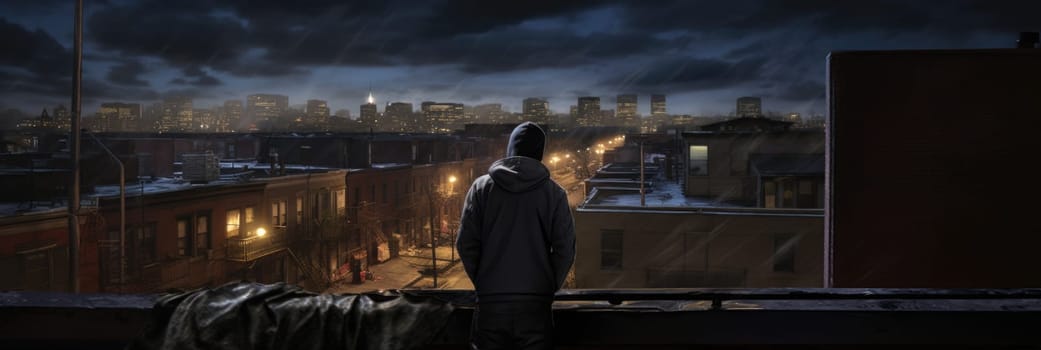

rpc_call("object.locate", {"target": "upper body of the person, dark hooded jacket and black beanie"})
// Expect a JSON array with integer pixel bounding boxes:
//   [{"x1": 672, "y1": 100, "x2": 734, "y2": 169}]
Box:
[{"x1": 456, "y1": 123, "x2": 575, "y2": 302}]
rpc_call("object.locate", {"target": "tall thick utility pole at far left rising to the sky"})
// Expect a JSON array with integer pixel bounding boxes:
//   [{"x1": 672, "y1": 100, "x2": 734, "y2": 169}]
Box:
[{"x1": 67, "y1": 0, "x2": 83, "y2": 293}]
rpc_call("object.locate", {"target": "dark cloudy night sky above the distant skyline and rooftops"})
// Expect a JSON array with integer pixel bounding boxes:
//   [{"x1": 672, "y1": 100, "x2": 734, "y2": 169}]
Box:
[{"x1": 0, "y1": 0, "x2": 1041, "y2": 116}]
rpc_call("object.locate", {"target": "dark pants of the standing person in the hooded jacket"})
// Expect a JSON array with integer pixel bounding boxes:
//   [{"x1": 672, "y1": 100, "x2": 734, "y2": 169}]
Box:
[{"x1": 471, "y1": 301, "x2": 553, "y2": 350}]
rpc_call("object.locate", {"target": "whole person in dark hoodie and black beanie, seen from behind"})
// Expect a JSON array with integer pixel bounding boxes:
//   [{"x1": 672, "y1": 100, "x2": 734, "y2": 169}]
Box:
[{"x1": 456, "y1": 122, "x2": 575, "y2": 350}]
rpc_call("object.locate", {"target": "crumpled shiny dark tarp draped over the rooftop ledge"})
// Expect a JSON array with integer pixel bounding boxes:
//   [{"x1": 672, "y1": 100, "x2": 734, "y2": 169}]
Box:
[{"x1": 128, "y1": 282, "x2": 453, "y2": 350}]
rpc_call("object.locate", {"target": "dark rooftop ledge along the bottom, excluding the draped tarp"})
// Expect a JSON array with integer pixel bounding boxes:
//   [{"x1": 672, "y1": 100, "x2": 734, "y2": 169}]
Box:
[{"x1": 0, "y1": 289, "x2": 1041, "y2": 349}]
